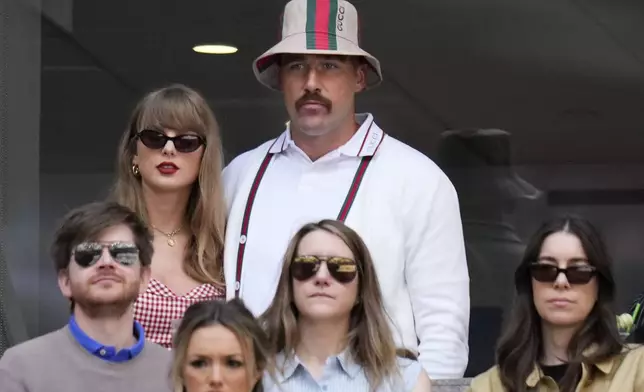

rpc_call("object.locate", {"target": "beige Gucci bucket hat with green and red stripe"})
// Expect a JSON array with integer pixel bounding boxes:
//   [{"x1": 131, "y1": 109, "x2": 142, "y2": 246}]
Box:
[{"x1": 253, "y1": 0, "x2": 382, "y2": 90}]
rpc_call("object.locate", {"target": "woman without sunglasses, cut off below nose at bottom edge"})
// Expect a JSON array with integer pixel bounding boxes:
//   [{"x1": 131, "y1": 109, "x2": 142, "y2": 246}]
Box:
[{"x1": 171, "y1": 300, "x2": 270, "y2": 392}]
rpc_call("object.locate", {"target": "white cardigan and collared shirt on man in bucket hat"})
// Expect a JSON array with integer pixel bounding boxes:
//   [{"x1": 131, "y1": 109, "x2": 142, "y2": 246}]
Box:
[{"x1": 224, "y1": 114, "x2": 470, "y2": 379}]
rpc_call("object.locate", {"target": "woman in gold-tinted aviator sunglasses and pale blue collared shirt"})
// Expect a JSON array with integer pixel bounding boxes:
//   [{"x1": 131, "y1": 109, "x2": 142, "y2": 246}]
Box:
[{"x1": 262, "y1": 220, "x2": 431, "y2": 392}]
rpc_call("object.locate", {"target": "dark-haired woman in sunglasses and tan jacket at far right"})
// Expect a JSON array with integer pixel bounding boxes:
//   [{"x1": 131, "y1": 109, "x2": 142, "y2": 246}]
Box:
[{"x1": 470, "y1": 216, "x2": 644, "y2": 392}]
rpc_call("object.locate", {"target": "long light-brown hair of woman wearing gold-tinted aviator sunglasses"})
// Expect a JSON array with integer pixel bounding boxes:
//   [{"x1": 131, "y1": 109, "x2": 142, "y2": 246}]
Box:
[{"x1": 260, "y1": 219, "x2": 416, "y2": 390}]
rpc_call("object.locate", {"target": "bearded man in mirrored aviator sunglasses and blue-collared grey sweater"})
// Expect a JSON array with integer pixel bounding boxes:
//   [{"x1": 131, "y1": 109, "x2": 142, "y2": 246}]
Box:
[{"x1": 0, "y1": 202, "x2": 172, "y2": 392}]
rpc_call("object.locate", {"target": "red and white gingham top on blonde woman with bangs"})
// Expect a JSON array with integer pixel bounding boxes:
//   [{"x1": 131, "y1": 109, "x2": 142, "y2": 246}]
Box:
[{"x1": 134, "y1": 278, "x2": 226, "y2": 348}]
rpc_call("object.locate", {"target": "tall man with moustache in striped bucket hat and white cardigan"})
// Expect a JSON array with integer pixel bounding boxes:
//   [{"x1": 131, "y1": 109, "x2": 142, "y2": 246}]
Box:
[{"x1": 224, "y1": 0, "x2": 470, "y2": 378}]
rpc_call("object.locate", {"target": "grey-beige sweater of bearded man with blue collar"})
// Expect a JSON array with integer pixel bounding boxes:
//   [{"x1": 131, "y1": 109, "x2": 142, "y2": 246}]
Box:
[{"x1": 0, "y1": 326, "x2": 172, "y2": 392}]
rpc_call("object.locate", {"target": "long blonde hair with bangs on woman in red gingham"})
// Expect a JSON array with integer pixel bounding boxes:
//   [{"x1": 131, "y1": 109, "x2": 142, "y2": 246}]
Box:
[{"x1": 110, "y1": 84, "x2": 226, "y2": 285}]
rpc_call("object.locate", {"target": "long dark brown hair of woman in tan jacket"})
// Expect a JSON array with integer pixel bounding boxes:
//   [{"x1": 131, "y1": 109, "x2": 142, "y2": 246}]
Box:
[{"x1": 496, "y1": 216, "x2": 623, "y2": 392}]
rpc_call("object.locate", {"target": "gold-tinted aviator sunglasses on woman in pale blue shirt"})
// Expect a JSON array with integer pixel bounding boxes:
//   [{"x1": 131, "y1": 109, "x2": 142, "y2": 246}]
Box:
[{"x1": 291, "y1": 256, "x2": 358, "y2": 283}]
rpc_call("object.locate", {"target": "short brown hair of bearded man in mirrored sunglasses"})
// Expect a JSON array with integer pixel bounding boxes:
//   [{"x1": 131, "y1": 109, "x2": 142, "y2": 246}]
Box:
[{"x1": 51, "y1": 202, "x2": 154, "y2": 273}]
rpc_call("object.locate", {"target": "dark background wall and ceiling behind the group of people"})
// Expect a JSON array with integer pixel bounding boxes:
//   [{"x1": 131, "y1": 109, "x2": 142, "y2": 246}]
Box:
[{"x1": 0, "y1": 0, "x2": 644, "y2": 376}]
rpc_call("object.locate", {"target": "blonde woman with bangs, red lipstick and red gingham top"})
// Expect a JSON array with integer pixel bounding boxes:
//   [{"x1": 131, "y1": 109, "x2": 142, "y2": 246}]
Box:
[{"x1": 112, "y1": 85, "x2": 226, "y2": 348}]
